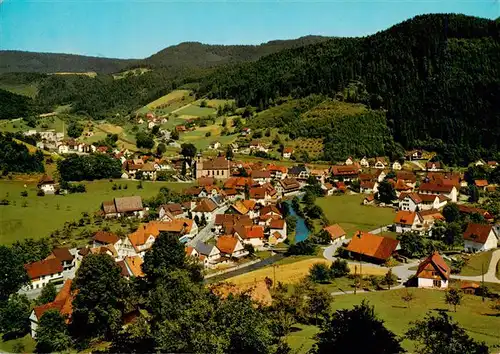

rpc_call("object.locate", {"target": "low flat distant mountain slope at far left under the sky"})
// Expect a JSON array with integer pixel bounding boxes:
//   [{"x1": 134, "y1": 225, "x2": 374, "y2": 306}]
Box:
[{"x1": 0, "y1": 50, "x2": 136, "y2": 74}]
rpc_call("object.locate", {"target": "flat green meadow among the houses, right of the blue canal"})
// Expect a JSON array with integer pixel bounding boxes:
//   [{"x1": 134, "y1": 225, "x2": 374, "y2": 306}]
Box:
[{"x1": 316, "y1": 195, "x2": 395, "y2": 237}]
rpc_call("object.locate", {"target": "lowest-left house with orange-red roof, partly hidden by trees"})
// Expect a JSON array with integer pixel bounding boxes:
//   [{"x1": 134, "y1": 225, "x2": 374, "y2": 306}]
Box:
[{"x1": 29, "y1": 279, "x2": 74, "y2": 338}]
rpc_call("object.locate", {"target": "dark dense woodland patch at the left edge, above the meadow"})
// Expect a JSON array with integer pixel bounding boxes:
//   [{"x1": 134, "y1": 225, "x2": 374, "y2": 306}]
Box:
[{"x1": 0, "y1": 134, "x2": 45, "y2": 175}]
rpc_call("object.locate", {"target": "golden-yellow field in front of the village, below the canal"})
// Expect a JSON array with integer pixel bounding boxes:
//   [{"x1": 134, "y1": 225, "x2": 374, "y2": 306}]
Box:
[{"x1": 226, "y1": 256, "x2": 385, "y2": 291}]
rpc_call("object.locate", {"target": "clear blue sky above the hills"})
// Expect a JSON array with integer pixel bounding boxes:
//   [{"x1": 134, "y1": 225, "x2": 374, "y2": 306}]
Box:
[{"x1": 0, "y1": 0, "x2": 500, "y2": 58}]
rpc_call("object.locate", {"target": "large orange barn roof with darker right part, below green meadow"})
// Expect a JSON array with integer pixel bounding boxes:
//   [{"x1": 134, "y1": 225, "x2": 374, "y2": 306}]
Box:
[{"x1": 347, "y1": 231, "x2": 399, "y2": 261}]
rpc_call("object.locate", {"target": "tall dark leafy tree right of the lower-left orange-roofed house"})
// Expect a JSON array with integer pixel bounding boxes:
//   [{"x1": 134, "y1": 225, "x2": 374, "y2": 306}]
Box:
[{"x1": 71, "y1": 254, "x2": 126, "y2": 341}]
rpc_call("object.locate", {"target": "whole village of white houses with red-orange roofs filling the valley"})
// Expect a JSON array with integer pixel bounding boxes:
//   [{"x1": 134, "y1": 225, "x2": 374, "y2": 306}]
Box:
[{"x1": 20, "y1": 149, "x2": 500, "y2": 337}]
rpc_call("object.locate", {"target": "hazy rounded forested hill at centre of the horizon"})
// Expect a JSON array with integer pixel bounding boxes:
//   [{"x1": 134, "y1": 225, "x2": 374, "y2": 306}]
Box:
[{"x1": 141, "y1": 36, "x2": 328, "y2": 68}]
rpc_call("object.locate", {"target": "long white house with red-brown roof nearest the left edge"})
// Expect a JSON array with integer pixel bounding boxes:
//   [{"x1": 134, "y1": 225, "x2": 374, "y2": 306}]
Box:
[{"x1": 23, "y1": 258, "x2": 64, "y2": 292}]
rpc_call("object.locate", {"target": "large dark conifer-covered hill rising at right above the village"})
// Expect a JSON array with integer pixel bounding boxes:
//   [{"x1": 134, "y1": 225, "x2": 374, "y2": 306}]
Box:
[{"x1": 200, "y1": 14, "x2": 500, "y2": 162}]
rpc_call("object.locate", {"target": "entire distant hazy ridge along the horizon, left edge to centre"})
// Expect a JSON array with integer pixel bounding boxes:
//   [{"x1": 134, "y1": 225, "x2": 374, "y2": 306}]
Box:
[{"x1": 0, "y1": 36, "x2": 328, "y2": 74}]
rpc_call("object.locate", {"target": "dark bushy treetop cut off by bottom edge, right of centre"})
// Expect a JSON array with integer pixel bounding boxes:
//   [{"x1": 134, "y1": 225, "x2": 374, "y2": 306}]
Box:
[{"x1": 313, "y1": 300, "x2": 404, "y2": 354}]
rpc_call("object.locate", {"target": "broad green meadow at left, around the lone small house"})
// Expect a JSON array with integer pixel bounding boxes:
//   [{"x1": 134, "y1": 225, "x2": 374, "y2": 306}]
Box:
[{"x1": 0, "y1": 180, "x2": 190, "y2": 244}]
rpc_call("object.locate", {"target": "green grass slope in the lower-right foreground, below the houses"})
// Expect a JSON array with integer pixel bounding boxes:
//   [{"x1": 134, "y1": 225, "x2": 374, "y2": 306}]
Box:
[{"x1": 287, "y1": 289, "x2": 500, "y2": 353}]
